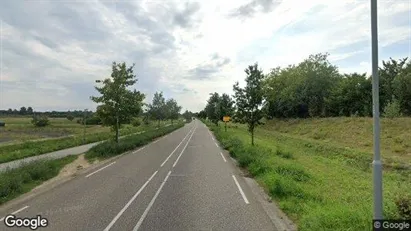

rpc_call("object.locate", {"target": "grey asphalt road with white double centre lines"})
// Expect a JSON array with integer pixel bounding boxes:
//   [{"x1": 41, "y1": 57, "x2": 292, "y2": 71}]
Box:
[{"x1": 0, "y1": 120, "x2": 276, "y2": 231}]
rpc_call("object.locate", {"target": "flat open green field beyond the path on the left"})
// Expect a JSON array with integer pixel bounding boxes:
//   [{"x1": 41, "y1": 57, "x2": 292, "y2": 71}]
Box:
[{"x1": 0, "y1": 118, "x2": 175, "y2": 163}]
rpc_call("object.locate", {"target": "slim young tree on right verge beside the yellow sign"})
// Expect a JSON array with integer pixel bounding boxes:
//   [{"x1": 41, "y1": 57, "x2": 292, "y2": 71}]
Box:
[{"x1": 233, "y1": 63, "x2": 264, "y2": 145}]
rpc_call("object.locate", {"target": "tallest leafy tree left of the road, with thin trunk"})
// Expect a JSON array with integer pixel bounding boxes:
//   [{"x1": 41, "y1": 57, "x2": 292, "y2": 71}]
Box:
[{"x1": 90, "y1": 62, "x2": 145, "y2": 143}]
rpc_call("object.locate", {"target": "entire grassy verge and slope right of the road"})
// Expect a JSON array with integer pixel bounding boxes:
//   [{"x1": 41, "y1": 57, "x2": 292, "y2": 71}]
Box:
[{"x1": 210, "y1": 118, "x2": 411, "y2": 231}]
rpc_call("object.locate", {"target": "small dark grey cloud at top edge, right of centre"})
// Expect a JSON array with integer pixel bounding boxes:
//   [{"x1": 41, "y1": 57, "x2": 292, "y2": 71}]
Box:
[{"x1": 229, "y1": 0, "x2": 280, "y2": 19}]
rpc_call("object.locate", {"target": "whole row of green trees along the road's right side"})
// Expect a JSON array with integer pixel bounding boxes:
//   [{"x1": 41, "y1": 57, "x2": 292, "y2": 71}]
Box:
[{"x1": 198, "y1": 53, "x2": 411, "y2": 143}]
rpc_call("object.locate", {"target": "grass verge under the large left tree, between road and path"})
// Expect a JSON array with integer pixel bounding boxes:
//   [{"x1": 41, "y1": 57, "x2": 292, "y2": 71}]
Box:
[{"x1": 85, "y1": 123, "x2": 184, "y2": 162}]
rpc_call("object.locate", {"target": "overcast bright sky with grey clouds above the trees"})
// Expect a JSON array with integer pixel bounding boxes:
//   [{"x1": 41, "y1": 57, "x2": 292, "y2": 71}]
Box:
[{"x1": 0, "y1": 0, "x2": 411, "y2": 111}]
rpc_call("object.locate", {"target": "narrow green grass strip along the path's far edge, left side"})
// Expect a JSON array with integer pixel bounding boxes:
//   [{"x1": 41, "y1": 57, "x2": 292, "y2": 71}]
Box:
[{"x1": 0, "y1": 125, "x2": 153, "y2": 163}]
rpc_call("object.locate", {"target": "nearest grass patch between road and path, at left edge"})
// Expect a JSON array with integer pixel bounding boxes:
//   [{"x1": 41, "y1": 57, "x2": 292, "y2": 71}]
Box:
[{"x1": 0, "y1": 156, "x2": 77, "y2": 205}]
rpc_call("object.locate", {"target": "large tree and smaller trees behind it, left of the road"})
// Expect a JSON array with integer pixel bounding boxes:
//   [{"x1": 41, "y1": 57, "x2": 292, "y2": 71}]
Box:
[{"x1": 90, "y1": 62, "x2": 181, "y2": 143}]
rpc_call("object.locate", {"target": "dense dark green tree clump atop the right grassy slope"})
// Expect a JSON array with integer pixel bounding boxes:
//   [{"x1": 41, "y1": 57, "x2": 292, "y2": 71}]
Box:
[{"x1": 264, "y1": 54, "x2": 411, "y2": 118}]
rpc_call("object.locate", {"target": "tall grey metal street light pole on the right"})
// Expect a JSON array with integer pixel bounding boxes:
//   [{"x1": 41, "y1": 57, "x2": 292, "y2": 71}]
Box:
[{"x1": 371, "y1": 0, "x2": 383, "y2": 219}]
